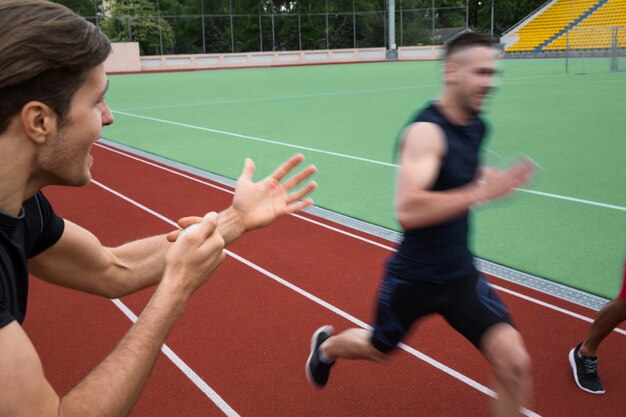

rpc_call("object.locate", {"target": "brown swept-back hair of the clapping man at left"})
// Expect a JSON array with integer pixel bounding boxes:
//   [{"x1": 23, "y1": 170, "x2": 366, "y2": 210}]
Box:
[{"x1": 0, "y1": 0, "x2": 111, "y2": 134}]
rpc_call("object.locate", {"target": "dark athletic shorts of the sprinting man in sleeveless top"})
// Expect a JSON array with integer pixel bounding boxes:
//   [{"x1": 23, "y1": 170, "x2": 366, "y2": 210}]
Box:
[{"x1": 372, "y1": 273, "x2": 513, "y2": 353}]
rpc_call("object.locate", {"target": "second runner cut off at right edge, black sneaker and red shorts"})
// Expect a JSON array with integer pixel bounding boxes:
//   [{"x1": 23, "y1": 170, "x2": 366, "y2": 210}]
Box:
[{"x1": 569, "y1": 259, "x2": 626, "y2": 394}]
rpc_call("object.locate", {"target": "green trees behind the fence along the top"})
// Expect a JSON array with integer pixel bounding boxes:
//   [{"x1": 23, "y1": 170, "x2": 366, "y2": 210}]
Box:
[{"x1": 53, "y1": 0, "x2": 546, "y2": 55}]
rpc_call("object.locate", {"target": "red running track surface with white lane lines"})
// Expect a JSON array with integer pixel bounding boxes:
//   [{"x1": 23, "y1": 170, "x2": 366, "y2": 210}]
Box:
[{"x1": 25, "y1": 144, "x2": 626, "y2": 417}]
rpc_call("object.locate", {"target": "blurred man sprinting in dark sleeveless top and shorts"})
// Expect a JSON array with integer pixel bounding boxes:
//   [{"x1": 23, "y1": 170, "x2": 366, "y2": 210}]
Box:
[{"x1": 306, "y1": 33, "x2": 534, "y2": 417}]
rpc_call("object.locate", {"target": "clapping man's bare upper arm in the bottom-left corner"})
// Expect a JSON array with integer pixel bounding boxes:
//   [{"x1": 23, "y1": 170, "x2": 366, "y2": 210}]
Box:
[{"x1": 0, "y1": 321, "x2": 60, "y2": 417}]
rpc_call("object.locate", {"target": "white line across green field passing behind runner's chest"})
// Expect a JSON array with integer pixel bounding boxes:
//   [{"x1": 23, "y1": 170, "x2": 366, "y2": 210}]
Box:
[{"x1": 102, "y1": 111, "x2": 626, "y2": 211}]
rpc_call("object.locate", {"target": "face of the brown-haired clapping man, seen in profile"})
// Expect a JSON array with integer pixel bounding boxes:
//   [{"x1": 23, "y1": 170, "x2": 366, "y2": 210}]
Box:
[{"x1": 39, "y1": 65, "x2": 113, "y2": 185}]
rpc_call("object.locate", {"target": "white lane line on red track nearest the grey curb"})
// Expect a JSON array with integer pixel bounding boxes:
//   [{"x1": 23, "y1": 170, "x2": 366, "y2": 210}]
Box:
[{"x1": 97, "y1": 144, "x2": 626, "y2": 335}]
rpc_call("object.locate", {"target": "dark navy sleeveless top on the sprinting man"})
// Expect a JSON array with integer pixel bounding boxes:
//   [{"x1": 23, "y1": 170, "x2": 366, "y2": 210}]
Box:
[{"x1": 387, "y1": 103, "x2": 486, "y2": 283}]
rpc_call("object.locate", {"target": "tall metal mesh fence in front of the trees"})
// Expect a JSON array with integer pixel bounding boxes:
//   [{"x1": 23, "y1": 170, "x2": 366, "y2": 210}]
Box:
[{"x1": 75, "y1": 0, "x2": 469, "y2": 55}]
